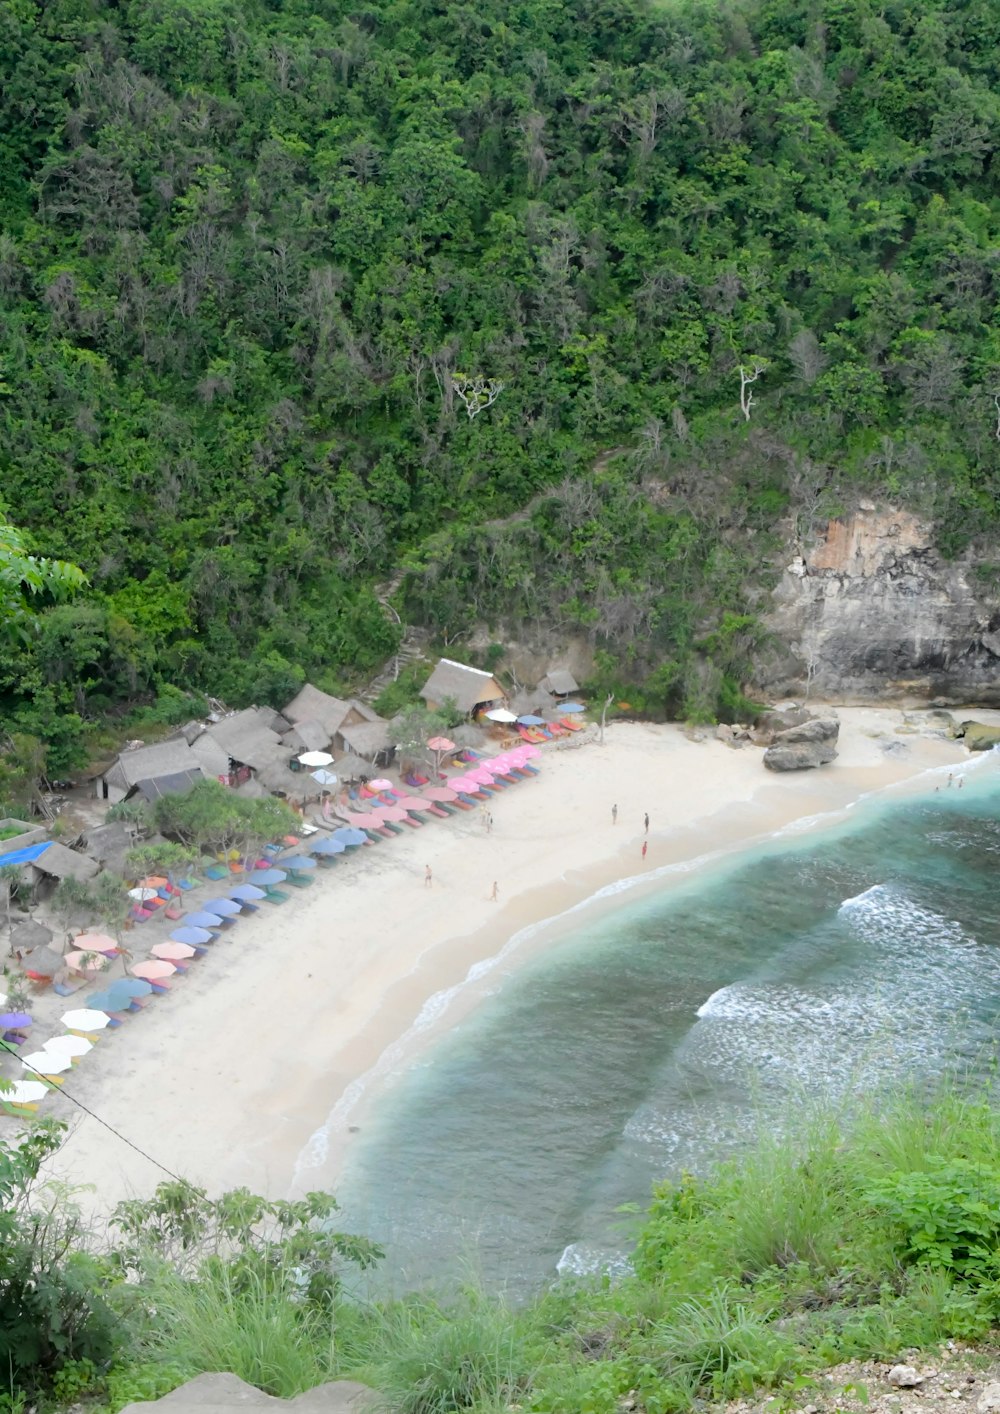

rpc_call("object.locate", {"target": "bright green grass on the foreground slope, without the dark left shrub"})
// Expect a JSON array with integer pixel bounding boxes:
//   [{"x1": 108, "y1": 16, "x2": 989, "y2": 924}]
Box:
[{"x1": 13, "y1": 1087, "x2": 1000, "y2": 1414}]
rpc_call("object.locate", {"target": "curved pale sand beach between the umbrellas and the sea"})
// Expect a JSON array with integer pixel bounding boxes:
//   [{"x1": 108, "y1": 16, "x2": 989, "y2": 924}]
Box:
[{"x1": 33, "y1": 708, "x2": 969, "y2": 1213}]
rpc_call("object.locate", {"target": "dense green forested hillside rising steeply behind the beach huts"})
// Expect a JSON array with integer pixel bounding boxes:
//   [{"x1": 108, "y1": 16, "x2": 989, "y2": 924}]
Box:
[{"x1": 0, "y1": 0, "x2": 1000, "y2": 752}]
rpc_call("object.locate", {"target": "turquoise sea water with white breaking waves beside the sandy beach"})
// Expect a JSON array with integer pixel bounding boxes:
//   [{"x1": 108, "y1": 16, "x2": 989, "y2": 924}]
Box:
[{"x1": 338, "y1": 764, "x2": 1000, "y2": 1288}]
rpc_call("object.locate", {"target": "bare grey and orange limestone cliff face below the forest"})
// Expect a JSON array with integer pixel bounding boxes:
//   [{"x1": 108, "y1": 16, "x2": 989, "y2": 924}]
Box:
[{"x1": 758, "y1": 503, "x2": 1000, "y2": 703}]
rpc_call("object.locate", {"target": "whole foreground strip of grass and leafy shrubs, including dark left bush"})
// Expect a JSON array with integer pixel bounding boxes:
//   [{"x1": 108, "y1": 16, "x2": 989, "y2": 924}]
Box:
[{"x1": 7, "y1": 1089, "x2": 1000, "y2": 1414}]
